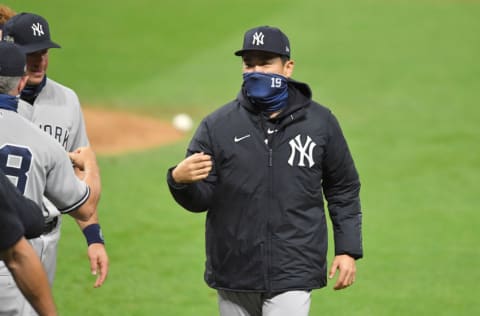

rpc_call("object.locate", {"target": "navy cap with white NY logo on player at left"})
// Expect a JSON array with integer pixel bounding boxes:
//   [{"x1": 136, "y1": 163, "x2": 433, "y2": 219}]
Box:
[{"x1": 3, "y1": 12, "x2": 60, "y2": 54}]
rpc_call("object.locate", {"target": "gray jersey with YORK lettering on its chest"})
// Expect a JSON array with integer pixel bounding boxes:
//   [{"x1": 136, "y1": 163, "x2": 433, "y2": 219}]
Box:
[{"x1": 18, "y1": 78, "x2": 89, "y2": 151}]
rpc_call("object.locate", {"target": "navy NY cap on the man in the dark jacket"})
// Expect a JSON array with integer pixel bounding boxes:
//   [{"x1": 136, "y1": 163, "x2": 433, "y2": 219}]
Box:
[{"x1": 235, "y1": 26, "x2": 290, "y2": 58}]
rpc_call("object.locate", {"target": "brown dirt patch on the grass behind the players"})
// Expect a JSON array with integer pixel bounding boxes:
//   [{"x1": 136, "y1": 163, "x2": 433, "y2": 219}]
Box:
[{"x1": 83, "y1": 107, "x2": 185, "y2": 155}]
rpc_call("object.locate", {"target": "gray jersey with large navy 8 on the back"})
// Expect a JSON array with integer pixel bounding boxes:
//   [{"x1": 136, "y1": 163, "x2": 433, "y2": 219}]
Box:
[{"x1": 0, "y1": 109, "x2": 89, "y2": 215}]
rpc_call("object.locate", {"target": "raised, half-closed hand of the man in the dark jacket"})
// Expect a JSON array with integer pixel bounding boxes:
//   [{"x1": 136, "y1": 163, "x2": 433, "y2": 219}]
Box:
[{"x1": 172, "y1": 153, "x2": 212, "y2": 183}]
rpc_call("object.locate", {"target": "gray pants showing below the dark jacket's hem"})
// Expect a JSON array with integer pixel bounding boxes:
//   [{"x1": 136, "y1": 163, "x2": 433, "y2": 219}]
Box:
[{"x1": 217, "y1": 290, "x2": 311, "y2": 316}]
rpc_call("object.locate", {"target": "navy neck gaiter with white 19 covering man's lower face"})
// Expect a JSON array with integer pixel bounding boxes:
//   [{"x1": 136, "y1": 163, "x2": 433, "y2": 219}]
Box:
[{"x1": 243, "y1": 72, "x2": 288, "y2": 113}]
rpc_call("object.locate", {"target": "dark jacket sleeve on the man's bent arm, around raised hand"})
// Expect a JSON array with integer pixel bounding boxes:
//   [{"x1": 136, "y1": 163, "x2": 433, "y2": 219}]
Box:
[{"x1": 167, "y1": 120, "x2": 217, "y2": 212}]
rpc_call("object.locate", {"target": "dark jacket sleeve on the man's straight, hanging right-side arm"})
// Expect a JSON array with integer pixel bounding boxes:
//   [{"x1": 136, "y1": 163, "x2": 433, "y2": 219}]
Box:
[{"x1": 323, "y1": 114, "x2": 363, "y2": 259}]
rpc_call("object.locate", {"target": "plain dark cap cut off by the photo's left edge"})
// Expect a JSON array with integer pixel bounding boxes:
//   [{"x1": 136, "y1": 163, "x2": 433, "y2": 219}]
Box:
[{"x1": 0, "y1": 41, "x2": 26, "y2": 77}]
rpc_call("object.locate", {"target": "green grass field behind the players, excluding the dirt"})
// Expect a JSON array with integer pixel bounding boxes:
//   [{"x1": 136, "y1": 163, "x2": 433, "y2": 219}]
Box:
[{"x1": 3, "y1": 0, "x2": 480, "y2": 316}]
